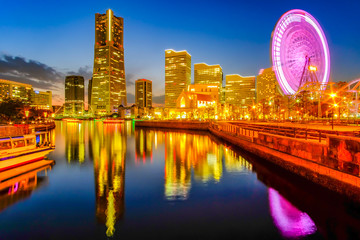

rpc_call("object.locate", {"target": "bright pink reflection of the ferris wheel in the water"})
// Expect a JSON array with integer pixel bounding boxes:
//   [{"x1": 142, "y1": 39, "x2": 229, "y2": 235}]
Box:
[{"x1": 269, "y1": 188, "x2": 317, "y2": 238}]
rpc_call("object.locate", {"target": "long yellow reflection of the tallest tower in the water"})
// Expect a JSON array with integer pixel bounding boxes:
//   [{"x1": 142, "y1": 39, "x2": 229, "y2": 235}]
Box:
[{"x1": 89, "y1": 122, "x2": 126, "y2": 237}]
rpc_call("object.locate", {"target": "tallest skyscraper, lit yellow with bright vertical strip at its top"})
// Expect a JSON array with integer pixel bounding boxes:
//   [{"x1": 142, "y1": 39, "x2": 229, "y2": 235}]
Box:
[{"x1": 91, "y1": 9, "x2": 127, "y2": 115}]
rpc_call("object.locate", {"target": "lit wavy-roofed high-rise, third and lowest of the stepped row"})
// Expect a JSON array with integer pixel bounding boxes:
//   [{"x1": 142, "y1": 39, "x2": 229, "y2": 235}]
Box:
[{"x1": 225, "y1": 74, "x2": 255, "y2": 107}]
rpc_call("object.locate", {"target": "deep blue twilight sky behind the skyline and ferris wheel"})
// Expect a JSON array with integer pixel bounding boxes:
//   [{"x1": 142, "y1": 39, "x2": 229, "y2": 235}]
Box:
[{"x1": 0, "y1": 0, "x2": 360, "y2": 104}]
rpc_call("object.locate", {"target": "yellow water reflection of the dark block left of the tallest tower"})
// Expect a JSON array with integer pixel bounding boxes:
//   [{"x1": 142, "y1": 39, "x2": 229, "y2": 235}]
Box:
[{"x1": 63, "y1": 122, "x2": 85, "y2": 164}]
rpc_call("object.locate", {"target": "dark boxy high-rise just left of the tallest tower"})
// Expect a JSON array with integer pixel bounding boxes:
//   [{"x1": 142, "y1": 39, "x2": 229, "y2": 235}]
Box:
[{"x1": 64, "y1": 76, "x2": 85, "y2": 115}]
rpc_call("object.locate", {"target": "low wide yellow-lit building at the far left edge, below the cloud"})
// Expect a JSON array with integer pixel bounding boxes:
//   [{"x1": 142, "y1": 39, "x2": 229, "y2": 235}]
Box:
[{"x1": 0, "y1": 79, "x2": 33, "y2": 102}]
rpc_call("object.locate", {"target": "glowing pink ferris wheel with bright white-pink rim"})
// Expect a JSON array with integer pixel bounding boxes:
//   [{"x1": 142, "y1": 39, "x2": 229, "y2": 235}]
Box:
[{"x1": 271, "y1": 9, "x2": 330, "y2": 95}]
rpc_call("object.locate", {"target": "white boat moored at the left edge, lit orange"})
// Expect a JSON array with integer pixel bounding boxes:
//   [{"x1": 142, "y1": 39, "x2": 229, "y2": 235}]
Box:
[{"x1": 0, "y1": 132, "x2": 54, "y2": 172}]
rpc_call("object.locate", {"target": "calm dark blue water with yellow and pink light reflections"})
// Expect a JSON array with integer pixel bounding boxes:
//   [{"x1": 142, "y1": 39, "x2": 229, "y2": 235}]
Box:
[{"x1": 0, "y1": 121, "x2": 360, "y2": 239}]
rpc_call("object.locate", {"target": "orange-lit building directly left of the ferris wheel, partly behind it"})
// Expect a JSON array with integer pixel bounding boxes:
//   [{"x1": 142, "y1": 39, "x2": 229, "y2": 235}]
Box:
[{"x1": 256, "y1": 67, "x2": 283, "y2": 102}]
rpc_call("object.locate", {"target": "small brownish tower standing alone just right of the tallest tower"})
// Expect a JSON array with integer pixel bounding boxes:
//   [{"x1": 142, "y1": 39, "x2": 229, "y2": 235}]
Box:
[{"x1": 135, "y1": 79, "x2": 152, "y2": 108}]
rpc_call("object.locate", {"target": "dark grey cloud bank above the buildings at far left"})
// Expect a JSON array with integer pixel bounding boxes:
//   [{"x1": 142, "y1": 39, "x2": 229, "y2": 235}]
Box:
[{"x1": 0, "y1": 54, "x2": 64, "y2": 90}]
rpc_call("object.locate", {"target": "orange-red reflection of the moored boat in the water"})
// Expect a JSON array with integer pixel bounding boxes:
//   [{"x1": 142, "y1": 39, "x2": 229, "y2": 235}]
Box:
[{"x1": 0, "y1": 160, "x2": 54, "y2": 212}]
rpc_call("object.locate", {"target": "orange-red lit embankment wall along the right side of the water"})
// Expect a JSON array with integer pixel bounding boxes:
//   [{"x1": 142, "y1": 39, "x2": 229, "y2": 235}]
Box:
[{"x1": 135, "y1": 121, "x2": 360, "y2": 201}]
